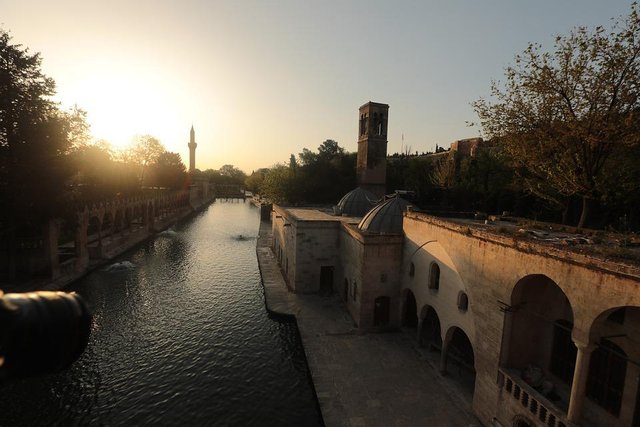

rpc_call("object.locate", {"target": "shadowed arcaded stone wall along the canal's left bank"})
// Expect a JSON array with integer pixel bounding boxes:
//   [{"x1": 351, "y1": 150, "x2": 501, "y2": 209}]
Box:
[{"x1": 2, "y1": 183, "x2": 215, "y2": 292}]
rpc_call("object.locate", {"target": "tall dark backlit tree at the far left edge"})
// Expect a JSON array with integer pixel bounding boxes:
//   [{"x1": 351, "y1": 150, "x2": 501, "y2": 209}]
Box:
[{"x1": 0, "y1": 30, "x2": 82, "y2": 277}]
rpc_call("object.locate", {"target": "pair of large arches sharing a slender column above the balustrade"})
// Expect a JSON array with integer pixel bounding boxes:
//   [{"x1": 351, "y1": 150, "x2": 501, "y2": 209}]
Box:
[{"x1": 501, "y1": 274, "x2": 640, "y2": 426}]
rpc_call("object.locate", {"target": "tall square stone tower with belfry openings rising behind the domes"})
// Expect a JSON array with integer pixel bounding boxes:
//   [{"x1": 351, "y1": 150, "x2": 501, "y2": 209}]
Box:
[{"x1": 356, "y1": 102, "x2": 389, "y2": 197}]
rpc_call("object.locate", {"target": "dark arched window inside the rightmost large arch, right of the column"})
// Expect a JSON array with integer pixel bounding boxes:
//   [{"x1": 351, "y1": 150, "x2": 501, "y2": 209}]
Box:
[{"x1": 587, "y1": 340, "x2": 627, "y2": 416}]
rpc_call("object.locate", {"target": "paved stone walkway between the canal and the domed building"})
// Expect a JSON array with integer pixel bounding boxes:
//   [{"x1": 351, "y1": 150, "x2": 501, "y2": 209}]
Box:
[{"x1": 257, "y1": 222, "x2": 481, "y2": 427}]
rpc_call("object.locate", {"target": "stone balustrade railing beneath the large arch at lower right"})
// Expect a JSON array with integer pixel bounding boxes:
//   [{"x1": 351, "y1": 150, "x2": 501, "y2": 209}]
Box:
[{"x1": 500, "y1": 369, "x2": 575, "y2": 427}]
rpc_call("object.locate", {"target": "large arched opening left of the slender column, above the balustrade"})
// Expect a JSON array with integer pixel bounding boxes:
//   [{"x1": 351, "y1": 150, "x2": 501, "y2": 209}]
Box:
[{"x1": 503, "y1": 274, "x2": 576, "y2": 385}]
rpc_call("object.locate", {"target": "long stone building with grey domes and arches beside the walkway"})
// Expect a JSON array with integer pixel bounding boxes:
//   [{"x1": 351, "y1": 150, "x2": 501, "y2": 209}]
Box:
[{"x1": 272, "y1": 104, "x2": 640, "y2": 427}]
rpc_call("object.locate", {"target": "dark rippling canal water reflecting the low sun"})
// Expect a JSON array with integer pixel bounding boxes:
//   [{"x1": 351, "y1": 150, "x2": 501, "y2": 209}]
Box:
[{"x1": 0, "y1": 201, "x2": 322, "y2": 426}]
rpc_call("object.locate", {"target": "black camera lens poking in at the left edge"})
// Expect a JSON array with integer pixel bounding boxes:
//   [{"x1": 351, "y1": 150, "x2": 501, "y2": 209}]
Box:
[{"x1": 0, "y1": 292, "x2": 91, "y2": 377}]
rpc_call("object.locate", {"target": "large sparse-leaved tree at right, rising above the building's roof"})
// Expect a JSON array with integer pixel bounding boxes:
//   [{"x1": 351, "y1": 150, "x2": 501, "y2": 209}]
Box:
[{"x1": 474, "y1": 3, "x2": 640, "y2": 227}]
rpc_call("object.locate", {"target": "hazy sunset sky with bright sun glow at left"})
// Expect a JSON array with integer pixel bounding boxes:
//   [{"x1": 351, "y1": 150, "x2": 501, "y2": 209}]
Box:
[{"x1": 0, "y1": 0, "x2": 631, "y2": 173}]
